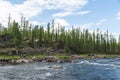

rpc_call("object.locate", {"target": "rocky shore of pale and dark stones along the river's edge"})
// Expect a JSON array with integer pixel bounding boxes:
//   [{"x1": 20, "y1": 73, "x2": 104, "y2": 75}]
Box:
[{"x1": 0, "y1": 54, "x2": 106, "y2": 65}]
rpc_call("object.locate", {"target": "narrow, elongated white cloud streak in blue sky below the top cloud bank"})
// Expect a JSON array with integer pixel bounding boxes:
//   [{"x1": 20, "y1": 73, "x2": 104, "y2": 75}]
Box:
[{"x1": 52, "y1": 11, "x2": 90, "y2": 17}]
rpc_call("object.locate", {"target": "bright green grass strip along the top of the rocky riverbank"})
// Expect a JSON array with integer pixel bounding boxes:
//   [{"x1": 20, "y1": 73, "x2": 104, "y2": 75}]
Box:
[{"x1": 0, "y1": 53, "x2": 120, "y2": 60}]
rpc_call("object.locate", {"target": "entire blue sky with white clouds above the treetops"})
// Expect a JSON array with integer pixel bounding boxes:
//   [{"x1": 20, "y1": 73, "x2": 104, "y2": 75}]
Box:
[{"x1": 0, "y1": 0, "x2": 120, "y2": 36}]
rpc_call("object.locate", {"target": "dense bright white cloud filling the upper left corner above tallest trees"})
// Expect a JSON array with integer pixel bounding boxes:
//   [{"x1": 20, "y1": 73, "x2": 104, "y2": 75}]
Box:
[{"x1": 0, "y1": 0, "x2": 42, "y2": 26}]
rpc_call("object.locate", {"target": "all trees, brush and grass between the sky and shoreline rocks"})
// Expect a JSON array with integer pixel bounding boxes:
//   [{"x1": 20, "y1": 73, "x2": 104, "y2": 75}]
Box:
[{"x1": 0, "y1": 15, "x2": 120, "y2": 62}]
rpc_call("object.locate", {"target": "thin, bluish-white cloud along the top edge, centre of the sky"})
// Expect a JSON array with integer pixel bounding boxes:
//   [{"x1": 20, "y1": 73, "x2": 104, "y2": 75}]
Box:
[{"x1": 42, "y1": 0, "x2": 88, "y2": 11}]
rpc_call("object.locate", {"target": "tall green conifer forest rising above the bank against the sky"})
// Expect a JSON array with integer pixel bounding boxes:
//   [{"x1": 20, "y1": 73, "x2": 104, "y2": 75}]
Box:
[{"x1": 0, "y1": 15, "x2": 120, "y2": 54}]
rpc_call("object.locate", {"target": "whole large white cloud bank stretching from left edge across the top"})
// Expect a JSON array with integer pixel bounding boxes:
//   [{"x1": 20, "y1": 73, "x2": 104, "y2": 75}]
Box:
[{"x1": 0, "y1": 0, "x2": 88, "y2": 26}]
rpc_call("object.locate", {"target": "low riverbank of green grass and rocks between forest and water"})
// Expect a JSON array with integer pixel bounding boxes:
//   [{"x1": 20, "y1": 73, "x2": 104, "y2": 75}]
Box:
[{"x1": 0, "y1": 54, "x2": 120, "y2": 65}]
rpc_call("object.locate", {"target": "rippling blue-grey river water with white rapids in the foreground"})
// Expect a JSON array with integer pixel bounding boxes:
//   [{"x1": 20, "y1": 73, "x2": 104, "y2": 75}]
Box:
[{"x1": 0, "y1": 58, "x2": 120, "y2": 80}]
